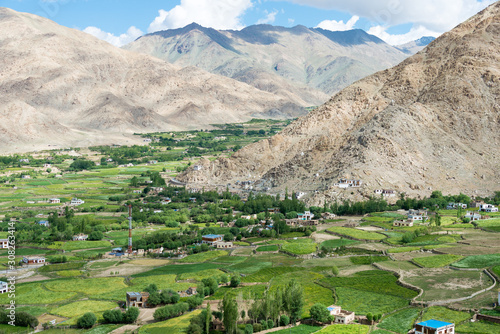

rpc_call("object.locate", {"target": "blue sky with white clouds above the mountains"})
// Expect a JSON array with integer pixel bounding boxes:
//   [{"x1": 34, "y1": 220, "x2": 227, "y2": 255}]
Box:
[{"x1": 0, "y1": 0, "x2": 495, "y2": 46}]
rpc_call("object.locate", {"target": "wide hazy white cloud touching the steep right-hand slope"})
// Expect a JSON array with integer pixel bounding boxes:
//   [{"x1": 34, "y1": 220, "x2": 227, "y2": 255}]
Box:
[{"x1": 285, "y1": 0, "x2": 496, "y2": 32}]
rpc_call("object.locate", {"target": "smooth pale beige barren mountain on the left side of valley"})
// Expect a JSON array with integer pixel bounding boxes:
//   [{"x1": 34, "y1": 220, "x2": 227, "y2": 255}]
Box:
[{"x1": 0, "y1": 8, "x2": 302, "y2": 152}]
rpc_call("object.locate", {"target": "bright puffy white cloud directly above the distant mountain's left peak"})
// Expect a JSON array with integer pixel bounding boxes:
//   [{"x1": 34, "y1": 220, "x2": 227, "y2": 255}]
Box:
[{"x1": 148, "y1": 0, "x2": 252, "y2": 33}]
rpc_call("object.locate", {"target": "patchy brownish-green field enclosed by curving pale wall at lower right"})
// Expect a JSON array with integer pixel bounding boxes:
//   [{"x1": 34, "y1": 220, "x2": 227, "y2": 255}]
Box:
[{"x1": 404, "y1": 269, "x2": 492, "y2": 301}]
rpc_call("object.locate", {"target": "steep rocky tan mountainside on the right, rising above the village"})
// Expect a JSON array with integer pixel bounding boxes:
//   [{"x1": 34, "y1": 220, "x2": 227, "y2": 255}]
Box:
[{"x1": 179, "y1": 2, "x2": 500, "y2": 204}]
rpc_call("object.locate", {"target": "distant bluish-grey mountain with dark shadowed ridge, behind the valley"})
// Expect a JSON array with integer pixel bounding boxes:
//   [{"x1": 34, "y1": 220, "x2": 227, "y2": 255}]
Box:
[{"x1": 124, "y1": 23, "x2": 408, "y2": 105}]
